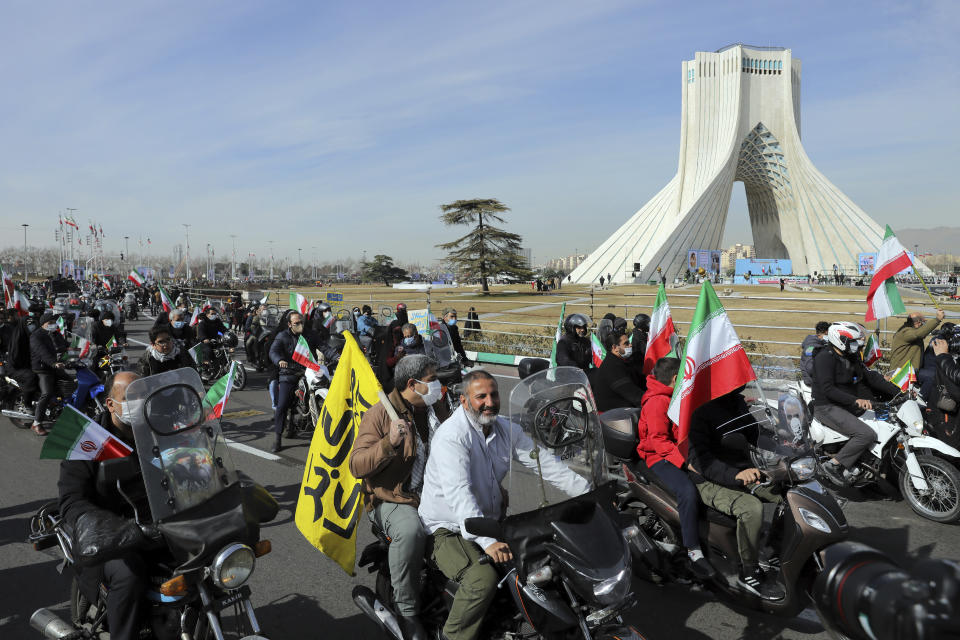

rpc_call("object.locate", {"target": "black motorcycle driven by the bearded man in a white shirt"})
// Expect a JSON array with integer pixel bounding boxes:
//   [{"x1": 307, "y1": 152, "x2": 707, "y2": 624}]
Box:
[{"x1": 353, "y1": 367, "x2": 641, "y2": 640}]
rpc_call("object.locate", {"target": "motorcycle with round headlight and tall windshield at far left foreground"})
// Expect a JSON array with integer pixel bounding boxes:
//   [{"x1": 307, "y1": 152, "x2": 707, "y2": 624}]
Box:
[{"x1": 29, "y1": 368, "x2": 279, "y2": 640}]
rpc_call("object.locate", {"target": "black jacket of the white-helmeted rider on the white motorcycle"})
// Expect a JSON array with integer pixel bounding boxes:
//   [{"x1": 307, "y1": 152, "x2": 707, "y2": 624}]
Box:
[{"x1": 813, "y1": 346, "x2": 900, "y2": 415}]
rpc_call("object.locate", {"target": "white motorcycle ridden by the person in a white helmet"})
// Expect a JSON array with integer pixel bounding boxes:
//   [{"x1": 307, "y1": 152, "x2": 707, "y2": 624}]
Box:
[{"x1": 798, "y1": 382, "x2": 960, "y2": 522}]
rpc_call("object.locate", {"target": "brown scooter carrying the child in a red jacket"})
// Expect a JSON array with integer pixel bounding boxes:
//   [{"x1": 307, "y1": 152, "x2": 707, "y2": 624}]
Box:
[{"x1": 600, "y1": 388, "x2": 848, "y2": 616}]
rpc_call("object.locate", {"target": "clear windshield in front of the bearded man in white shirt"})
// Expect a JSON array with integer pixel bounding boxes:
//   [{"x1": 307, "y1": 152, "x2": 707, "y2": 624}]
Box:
[{"x1": 506, "y1": 367, "x2": 604, "y2": 515}]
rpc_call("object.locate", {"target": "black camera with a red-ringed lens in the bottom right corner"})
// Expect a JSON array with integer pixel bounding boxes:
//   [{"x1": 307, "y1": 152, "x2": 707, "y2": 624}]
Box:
[{"x1": 813, "y1": 542, "x2": 960, "y2": 640}]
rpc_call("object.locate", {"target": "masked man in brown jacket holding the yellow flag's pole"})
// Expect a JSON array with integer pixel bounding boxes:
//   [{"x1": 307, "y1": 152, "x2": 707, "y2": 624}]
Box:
[{"x1": 350, "y1": 354, "x2": 450, "y2": 640}]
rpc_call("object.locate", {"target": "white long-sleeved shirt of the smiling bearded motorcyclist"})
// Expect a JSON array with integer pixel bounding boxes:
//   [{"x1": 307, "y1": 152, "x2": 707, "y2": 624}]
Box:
[{"x1": 419, "y1": 406, "x2": 590, "y2": 549}]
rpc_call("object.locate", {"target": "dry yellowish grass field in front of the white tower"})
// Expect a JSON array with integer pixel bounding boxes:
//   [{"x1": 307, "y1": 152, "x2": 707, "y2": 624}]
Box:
[{"x1": 186, "y1": 286, "x2": 960, "y2": 379}]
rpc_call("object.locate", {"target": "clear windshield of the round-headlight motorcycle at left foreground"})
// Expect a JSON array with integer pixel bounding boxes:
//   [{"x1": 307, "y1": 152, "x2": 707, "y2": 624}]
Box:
[{"x1": 123, "y1": 367, "x2": 236, "y2": 521}]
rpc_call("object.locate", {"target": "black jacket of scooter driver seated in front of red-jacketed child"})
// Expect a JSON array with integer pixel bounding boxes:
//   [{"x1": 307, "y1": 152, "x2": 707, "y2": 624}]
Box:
[{"x1": 687, "y1": 394, "x2": 759, "y2": 489}]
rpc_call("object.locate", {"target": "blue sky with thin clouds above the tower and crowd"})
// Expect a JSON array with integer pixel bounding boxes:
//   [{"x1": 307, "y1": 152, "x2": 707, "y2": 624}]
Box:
[{"x1": 0, "y1": 0, "x2": 960, "y2": 263}]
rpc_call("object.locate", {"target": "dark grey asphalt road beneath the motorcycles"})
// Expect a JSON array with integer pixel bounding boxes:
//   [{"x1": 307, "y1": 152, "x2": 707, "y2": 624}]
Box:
[{"x1": 0, "y1": 321, "x2": 960, "y2": 640}]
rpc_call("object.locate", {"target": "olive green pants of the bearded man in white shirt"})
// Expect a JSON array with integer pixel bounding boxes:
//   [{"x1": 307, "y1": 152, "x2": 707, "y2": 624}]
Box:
[{"x1": 427, "y1": 529, "x2": 497, "y2": 640}]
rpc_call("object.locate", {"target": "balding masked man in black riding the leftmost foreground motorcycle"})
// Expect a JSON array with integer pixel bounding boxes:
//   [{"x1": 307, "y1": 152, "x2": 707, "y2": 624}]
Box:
[{"x1": 57, "y1": 371, "x2": 150, "y2": 640}]
